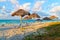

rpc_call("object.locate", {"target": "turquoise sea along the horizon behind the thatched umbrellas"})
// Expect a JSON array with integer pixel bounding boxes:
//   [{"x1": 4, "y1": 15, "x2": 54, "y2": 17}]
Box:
[{"x1": 0, "y1": 20, "x2": 60, "y2": 24}]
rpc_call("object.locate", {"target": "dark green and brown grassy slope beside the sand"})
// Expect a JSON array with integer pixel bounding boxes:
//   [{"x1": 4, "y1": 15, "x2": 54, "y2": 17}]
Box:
[{"x1": 24, "y1": 24, "x2": 60, "y2": 40}]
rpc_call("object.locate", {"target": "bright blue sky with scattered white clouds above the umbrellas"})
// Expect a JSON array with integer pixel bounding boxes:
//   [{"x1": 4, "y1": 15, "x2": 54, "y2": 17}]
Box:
[{"x1": 0, "y1": 0, "x2": 60, "y2": 19}]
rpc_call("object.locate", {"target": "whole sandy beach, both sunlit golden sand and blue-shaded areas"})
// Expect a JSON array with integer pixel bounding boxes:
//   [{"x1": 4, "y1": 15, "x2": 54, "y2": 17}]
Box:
[{"x1": 0, "y1": 22, "x2": 60, "y2": 40}]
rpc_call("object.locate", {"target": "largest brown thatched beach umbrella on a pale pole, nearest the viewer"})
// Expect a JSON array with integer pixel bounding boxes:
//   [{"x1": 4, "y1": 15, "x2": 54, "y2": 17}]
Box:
[{"x1": 12, "y1": 9, "x2": 30, "y2": 27}]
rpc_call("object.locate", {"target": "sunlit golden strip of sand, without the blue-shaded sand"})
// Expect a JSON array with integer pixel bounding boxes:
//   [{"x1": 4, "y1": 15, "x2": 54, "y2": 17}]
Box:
[{"x1": 0, "y1": 22, "x2": 60, "y2": 39}]
